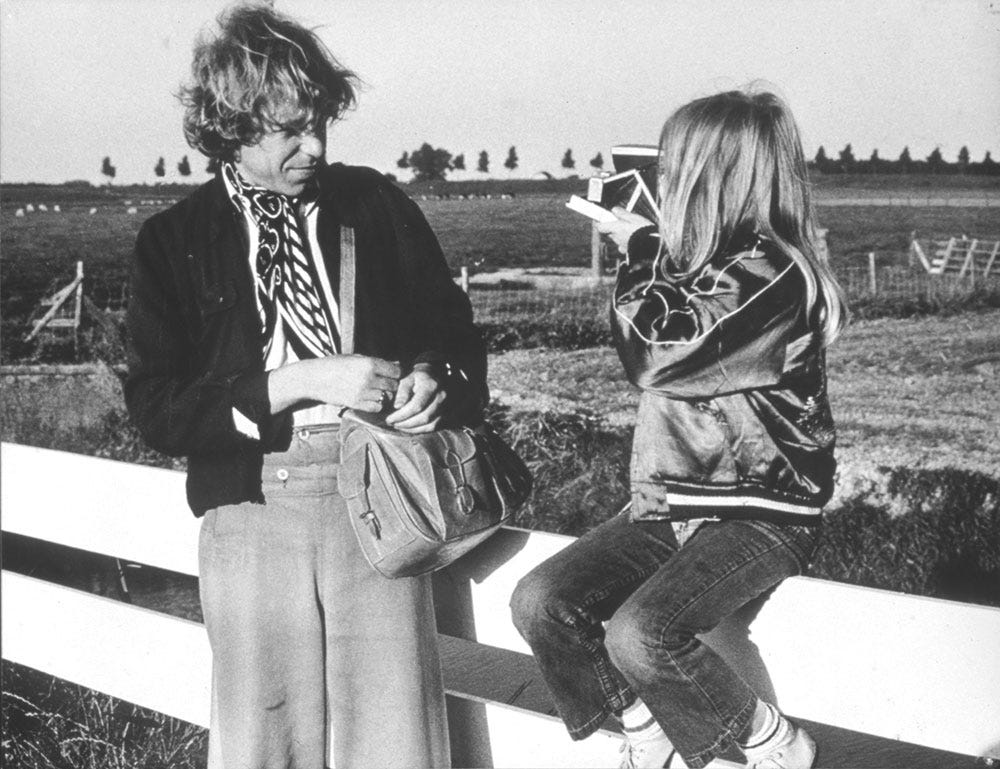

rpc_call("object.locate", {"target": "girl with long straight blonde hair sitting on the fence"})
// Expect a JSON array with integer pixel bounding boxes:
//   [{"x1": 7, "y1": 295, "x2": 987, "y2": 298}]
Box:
[{"x1": 511, "y1": 91, "x2": 847, "y2": 769}]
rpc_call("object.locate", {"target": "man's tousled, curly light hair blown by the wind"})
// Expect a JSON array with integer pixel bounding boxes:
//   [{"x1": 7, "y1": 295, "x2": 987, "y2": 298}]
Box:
[{"x1": 178, "y1": 4, "x2": 357, "y2": 160}]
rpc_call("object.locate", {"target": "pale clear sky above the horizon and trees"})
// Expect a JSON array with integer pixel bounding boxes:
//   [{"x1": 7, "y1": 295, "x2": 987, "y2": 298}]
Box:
[{"x1": 0, "y1": 0, "x2": 1000, "y2": 183}]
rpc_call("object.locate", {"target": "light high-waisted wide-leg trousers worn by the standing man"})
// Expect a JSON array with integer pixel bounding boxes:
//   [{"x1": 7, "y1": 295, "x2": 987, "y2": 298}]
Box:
[{"x1": 199, "y1": 429, "x2": 450, "y2": 769}]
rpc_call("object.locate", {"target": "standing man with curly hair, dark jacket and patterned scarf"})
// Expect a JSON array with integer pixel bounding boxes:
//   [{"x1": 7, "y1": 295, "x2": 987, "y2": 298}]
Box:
[{"x1": 125, "y1": 5, "x2": 486, "y2": 769}]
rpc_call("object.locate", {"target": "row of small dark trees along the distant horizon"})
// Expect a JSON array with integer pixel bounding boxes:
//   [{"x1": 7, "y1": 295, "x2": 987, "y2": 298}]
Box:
[{"x1": 101, "y1": 142, "x2": 1000, "y2": 184}]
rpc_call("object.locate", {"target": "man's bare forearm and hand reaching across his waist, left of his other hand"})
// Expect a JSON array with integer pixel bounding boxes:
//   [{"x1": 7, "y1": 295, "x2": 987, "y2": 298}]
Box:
[{"x1": 268, "y1": 355, "x2": 401, "y2": 414}]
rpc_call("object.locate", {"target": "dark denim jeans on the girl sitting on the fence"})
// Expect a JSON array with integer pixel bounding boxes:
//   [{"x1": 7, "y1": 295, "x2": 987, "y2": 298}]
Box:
[{"x1": 511, "y1": 514, "x2": 818, "y2": 769}]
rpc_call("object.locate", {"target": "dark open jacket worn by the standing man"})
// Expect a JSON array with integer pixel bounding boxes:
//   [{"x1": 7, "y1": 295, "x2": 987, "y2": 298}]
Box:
[{"x1": 125, "y1": 164, "x2": 486, "y2": 515}]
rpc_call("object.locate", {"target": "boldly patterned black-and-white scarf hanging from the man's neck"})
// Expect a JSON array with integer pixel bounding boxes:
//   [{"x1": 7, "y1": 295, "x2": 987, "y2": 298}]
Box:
[{"x1": 222, "y1": 163, "x2": 340, "y2": 360}]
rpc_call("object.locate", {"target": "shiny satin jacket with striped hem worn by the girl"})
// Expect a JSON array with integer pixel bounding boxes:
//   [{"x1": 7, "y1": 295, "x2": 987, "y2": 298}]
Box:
[{"x1": 611, "y1": 228, "x2": 836, "y2": 523}]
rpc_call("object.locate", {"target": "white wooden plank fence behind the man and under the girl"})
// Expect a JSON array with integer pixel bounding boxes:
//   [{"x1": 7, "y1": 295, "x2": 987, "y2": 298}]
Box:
[{"x1": 0, "y1": 443, "x2": 1000, "y2": 767}]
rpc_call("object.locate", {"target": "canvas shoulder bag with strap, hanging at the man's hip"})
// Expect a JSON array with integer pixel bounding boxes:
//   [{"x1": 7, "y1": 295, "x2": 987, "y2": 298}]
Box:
[{"x1": 337, "y1": 227, "x2": 531, "y2": 577}]
